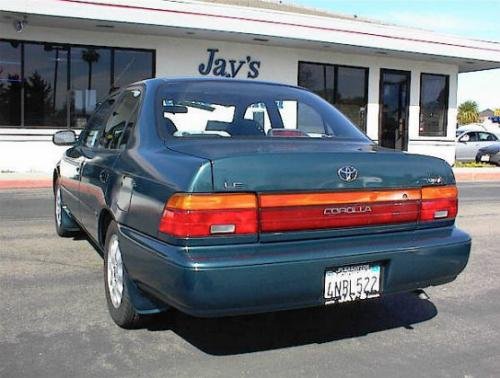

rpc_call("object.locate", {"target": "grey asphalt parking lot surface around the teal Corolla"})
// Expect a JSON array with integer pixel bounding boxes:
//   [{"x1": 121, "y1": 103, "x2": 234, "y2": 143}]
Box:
[{"x1": 0, "y1": 183, "x2": 500, "y2": 377}]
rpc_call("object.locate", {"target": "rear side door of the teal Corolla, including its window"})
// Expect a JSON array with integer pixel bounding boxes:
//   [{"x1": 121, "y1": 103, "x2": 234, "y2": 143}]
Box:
[{"x1": 79, "y1": 89, "x2": 140, "y2": 240}]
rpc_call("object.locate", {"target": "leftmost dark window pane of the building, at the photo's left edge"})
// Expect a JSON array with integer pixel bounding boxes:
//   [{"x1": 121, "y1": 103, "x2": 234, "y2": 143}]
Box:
[{"x1": 0, "y1": 41, "x2": 22, "y2": 126}]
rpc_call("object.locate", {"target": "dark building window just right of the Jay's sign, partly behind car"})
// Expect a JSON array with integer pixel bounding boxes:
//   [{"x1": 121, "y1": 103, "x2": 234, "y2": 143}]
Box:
[{"x1": 298, "y1": 62, "x2": 368, "y2": 131}]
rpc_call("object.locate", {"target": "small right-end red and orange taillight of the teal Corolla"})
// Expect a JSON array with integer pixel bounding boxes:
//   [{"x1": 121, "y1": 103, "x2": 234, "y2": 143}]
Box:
[{"x1": 420, "y1": 185, "x2": 458, "y2": 222}]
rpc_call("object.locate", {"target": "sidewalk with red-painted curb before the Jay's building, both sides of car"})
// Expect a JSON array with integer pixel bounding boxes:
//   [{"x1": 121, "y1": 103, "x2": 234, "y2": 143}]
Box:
[{"x1": 0, "y1": 167, "x2": 500, "y2": 189}]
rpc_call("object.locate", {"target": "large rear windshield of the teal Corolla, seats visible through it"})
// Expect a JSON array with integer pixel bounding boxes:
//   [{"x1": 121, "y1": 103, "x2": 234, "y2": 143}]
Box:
[{"x1": 156, "y1": 80, "x2": 368, "y2": 141}]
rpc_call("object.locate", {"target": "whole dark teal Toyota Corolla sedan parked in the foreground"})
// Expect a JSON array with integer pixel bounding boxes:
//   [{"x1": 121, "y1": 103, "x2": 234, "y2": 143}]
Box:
[{"x1": 53, "y1": 79, "x2": 471, "y2": 327}]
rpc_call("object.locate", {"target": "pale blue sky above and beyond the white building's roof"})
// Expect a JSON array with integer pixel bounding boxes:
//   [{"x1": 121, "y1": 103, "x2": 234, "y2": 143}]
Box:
[{"x1": 296, "y1": 0, "x2": 500, "y2": 109}]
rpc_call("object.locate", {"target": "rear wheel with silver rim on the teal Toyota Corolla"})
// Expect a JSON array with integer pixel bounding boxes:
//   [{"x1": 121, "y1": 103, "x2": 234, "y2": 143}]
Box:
[{"x1": 104, "y1": 221, "x2": 141, "y2": 329}]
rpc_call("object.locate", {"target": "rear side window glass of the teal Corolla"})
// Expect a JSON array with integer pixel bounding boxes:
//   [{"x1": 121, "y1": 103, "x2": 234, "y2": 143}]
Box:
[{"x1": 100, "y1": 89, "x2": 141, "y2": 149}]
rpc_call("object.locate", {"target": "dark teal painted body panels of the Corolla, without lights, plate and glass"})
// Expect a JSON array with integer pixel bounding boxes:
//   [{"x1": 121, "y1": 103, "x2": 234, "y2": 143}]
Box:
[{"x1": 57, "y1": 79, "x2": 470, "y2": 316}]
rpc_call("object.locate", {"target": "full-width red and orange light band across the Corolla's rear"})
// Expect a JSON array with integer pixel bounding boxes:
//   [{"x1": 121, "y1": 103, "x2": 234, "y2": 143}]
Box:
[{"x1": 159, "y1": 185, "x2": 458, "y2": 238}]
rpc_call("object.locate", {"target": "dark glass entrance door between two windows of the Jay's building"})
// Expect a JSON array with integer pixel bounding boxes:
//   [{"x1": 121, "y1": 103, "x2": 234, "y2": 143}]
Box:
[{"x1": 378, "y1": 69, "x2": 410, "y2": 150}]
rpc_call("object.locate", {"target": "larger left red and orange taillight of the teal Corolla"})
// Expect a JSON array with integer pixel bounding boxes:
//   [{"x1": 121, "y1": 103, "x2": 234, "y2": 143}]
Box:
[{"x1": 159, "y1": 193, "x2": 258, "y2": 238}]
